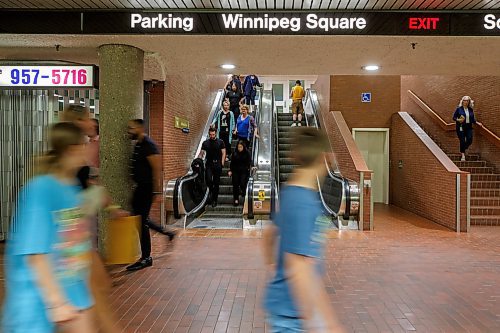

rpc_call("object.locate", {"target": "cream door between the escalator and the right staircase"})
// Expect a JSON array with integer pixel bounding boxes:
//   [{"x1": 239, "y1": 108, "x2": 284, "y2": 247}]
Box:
[{"x1": 353, "y1": 128, "x2": 389, "y2": 204}]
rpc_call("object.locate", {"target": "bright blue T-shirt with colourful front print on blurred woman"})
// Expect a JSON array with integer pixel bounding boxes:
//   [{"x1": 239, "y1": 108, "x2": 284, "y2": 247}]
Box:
[{"x1": 2, "y1": 175, "x2": 93, "y2": 333}]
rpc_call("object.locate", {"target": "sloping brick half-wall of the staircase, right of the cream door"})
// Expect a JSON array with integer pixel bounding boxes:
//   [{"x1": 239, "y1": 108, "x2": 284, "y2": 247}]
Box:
[{"x1": 390, "y1": 114, "x2": 467, "y2": 230}]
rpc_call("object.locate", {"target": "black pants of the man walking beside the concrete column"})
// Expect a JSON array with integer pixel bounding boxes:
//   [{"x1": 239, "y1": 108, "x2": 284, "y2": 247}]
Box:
[{"x1": 132, "y1": 184, "x2": 162, "y2": 259}]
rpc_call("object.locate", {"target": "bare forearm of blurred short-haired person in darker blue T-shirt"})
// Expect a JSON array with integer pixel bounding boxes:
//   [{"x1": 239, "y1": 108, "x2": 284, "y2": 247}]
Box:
[{"x1": 284, "y1": 253, "x2": 344, "y2": 332}]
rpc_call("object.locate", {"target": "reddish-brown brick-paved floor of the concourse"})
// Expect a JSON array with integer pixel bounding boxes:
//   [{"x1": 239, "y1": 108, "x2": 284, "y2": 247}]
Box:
[{"x1": 0, "y1": 205, "x2": 500, "y2": 333}]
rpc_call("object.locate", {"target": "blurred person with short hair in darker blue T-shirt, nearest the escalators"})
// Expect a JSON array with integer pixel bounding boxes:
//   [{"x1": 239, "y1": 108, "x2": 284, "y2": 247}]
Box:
[{"x1": 263, "y1": 128, "x2": 343, "y2": 333}]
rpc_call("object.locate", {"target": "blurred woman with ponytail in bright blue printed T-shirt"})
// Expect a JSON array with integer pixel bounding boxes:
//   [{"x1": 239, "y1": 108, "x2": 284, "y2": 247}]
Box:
[{"x1": 2, "y1": 123, "x2": 96, "y2": 333}]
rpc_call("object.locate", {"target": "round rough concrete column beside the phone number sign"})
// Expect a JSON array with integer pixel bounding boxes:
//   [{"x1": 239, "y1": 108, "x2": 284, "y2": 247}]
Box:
[{"x1": 99, "y1": 44, "x2": 144, "y2": 209}]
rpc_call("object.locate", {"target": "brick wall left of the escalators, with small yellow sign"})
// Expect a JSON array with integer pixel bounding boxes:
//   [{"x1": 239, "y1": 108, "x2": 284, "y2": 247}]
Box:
[{"x1": 150, "y1": 74, "x2": 227, "y2": 221}]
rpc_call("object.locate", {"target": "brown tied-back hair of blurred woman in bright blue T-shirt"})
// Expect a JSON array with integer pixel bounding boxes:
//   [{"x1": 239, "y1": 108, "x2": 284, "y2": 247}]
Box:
[{"x1": 37, "y1": 122, "x2": 84, "y2": 174}]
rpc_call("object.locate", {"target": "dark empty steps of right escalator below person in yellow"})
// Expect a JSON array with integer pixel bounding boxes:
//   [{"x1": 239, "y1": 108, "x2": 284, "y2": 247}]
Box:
[{"x1": 278, "y1": 113, "x2": 298, "y2": 186}]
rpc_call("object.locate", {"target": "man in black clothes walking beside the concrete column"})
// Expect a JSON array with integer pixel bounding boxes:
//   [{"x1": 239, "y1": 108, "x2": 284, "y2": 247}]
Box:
[{"x1": 127, "y1": 119, "x2": 175, "y2": 271}]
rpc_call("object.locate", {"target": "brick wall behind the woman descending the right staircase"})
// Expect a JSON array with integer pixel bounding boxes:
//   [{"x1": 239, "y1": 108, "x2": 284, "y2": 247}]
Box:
[{"x1": 401, "y1": 76, "x2": 500, "y2": 171}]
